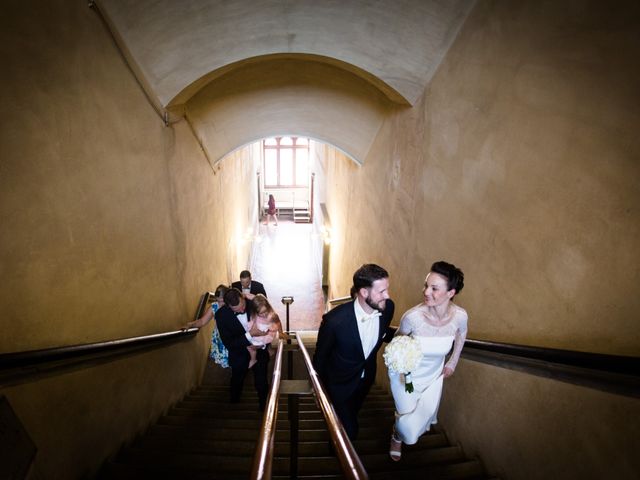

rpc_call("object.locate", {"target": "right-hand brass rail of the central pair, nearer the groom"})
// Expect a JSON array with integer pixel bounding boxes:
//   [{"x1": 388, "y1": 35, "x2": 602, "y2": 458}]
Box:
[{"x1": 296, "y1": 334, "x2": 369, "y2": 480}]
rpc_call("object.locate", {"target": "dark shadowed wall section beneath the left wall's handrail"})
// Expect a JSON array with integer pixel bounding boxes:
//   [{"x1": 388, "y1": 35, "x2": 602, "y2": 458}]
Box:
[{"x1": 0, "y1": 342, "x2": 206, "y2": 480}]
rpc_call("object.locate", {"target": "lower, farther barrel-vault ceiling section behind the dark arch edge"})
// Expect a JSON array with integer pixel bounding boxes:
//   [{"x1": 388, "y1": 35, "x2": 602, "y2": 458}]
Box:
[{"x1": 185, "y1": 59, "x2": 400, "y2": 163}]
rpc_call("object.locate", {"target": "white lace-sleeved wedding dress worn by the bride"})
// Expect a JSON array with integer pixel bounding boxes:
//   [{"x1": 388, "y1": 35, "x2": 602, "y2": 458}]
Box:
[{"x1": 389, "y1": 304, "x2": 467, "y2": 445}]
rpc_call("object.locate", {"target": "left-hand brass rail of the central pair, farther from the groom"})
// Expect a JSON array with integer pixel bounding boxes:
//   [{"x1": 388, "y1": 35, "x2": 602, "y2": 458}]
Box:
[{"x1": 250, "y1": 339, "x2": 284, "y2": 480}]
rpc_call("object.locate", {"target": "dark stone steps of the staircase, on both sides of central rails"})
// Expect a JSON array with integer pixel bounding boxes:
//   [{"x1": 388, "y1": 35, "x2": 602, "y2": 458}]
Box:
[{"x1": 97, "y1": 375, "x2": 496, "y2": 480}]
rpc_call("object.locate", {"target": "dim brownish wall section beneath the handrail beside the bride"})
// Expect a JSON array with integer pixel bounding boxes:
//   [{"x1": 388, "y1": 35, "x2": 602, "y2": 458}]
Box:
[{"x1": 438, "y1": 359, "x2": 640, "y2": 480}]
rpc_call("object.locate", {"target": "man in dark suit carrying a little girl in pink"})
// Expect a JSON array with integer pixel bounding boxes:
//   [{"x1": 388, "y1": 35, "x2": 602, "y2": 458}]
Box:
[{"x1": 216, "y1": 288, "x2": 273, "y2": 411}]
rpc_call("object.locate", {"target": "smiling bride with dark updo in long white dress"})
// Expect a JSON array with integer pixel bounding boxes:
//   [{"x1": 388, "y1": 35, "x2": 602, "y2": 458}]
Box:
[{"x1": 389, "y1": 261, "x2": 467, "y2": 462}]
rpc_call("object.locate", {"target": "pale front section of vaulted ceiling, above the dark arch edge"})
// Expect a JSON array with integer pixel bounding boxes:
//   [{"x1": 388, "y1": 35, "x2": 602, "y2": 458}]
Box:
[{"x1": 97, "y1": 0, "x2": 473, "y2": 107}]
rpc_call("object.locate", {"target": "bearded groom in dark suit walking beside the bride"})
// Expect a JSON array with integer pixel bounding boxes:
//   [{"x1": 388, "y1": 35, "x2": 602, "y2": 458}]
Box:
[{"x1": 313, "y1": 264, "x2": 395, "y2": 440}]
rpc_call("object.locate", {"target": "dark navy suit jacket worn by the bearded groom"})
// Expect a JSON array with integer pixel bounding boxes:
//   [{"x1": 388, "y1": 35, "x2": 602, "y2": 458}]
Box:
[{"x1": 313, "y1": 300, "x2": 395, "y2": 402}]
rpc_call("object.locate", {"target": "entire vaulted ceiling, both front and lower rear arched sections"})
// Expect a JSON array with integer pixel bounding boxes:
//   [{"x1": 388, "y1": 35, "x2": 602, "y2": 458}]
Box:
[{"x1": 95, "y1": 0, "x2": 474, "y2": 161}]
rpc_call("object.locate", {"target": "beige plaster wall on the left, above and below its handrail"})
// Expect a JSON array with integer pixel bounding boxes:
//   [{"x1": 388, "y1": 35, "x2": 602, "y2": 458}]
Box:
[{"x1": 0, "y1": 0, "x2": 256, "y2": 479}]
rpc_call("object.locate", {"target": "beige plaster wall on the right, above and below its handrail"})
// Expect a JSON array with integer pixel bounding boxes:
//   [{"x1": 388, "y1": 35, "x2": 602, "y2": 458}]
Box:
[{"x1": 320, "y1": 1, "x2": 640, "y2": 479}]
